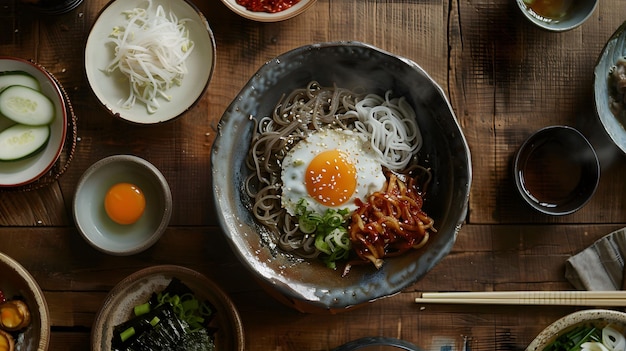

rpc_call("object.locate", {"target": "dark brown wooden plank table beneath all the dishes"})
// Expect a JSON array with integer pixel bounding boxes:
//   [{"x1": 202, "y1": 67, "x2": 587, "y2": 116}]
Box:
[{"x1": 0, "y1": 0, "x2": 626, "y2": 351}]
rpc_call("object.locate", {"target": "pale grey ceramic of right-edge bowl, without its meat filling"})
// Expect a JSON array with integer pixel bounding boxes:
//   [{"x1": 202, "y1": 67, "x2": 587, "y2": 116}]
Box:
[{"x1": 593, "y1": 22, "x2": 626, "y2": 153}]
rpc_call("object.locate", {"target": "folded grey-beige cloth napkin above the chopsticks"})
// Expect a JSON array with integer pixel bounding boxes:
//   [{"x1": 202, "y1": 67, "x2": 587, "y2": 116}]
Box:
[{"x1": 565, "y1": 228, "x2": 626, "y2": 291}]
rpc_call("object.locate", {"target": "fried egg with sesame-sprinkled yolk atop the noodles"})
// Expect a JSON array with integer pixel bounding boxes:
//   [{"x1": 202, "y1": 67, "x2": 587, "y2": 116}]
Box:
[{"x1": 281, "y1": 129, "x2": 385, "y2": 216}]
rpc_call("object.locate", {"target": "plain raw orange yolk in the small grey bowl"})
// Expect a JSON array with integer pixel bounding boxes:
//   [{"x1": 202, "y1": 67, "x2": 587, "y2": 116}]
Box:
[{"x1": 104, "y1": 183, "x2": 146, "y2": 224}]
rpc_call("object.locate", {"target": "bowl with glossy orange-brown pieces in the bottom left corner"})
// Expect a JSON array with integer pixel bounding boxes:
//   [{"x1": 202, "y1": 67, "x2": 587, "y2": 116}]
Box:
[{"x1": 0, "y1": 252, "x2": 50, "y2": 351}]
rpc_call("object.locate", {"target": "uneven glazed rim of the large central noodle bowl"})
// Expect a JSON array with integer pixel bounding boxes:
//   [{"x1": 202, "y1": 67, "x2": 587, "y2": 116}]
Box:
[{"x1": 211, "y1": 41, "x2": 472, "y2": 313}]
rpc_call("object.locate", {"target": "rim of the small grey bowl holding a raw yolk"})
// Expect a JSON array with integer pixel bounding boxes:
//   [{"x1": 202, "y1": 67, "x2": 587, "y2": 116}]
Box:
[{"x1": 72, "y1": 155, "x2": 172, "y2": 256}]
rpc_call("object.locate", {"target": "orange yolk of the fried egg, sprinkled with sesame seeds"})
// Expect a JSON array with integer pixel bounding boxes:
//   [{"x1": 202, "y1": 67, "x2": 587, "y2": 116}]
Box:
[{"x1": 304, "y1": 149, "x2": 356, "y2": 207}]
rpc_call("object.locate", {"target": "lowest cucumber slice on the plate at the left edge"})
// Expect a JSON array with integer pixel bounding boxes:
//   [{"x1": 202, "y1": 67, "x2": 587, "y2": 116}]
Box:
[{"x1": 0, "y1": 124, "x2": 50, "y2": 161}]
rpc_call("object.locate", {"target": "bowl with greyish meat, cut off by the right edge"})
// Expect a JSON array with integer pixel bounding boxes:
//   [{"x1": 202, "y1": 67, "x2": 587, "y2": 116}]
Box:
[{"x1": 593, "y1": 22, "x2": 626, "y2": 153}]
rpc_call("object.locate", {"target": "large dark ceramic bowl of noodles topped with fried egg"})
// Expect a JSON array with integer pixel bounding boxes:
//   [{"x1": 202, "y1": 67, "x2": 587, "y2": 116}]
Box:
[{"x1": 211, "y1": 42, "x2": 471, "y2": 312}]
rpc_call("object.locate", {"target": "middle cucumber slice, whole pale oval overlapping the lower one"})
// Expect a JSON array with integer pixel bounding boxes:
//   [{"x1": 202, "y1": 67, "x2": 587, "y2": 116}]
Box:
[{"x1": 0, "y1": 85, "x2": 54, "y2": 126}]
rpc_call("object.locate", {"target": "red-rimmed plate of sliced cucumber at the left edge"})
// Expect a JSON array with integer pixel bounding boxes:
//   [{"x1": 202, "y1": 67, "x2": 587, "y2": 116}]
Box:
[{"x1": 0, "y1": 56, "x2": 67, "y2": 187}]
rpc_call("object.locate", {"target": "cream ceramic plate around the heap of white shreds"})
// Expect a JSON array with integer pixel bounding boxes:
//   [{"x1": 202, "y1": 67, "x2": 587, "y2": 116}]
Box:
[{"x1": 85, "y1": 0, "x2": 215, "y2": 124}]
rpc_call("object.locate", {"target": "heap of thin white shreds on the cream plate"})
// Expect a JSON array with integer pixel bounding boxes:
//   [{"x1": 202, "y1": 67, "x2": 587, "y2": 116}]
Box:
[{"x1": 106, "y1": 0, "x2": 194, "y2": 113}]
